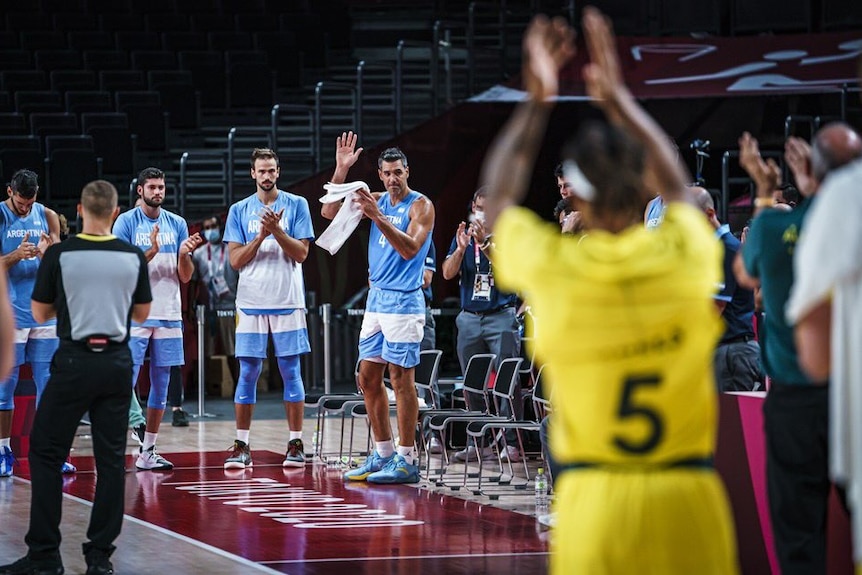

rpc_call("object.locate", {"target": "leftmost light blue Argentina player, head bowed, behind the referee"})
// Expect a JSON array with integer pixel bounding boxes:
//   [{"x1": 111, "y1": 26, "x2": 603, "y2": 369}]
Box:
[{"x1": 0, "y1": 170, "x2": 68, "y2": 477}]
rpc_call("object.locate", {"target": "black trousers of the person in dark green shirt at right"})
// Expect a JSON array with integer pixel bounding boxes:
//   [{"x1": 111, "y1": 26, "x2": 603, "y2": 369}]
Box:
[{"x1": 763, "y1": 382, "x2": 831, "y2": 575}]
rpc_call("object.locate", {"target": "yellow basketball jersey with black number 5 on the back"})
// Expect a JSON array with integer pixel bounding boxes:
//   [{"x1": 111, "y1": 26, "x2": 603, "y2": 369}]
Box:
[{"x1": 494, "y1": 204, "x2": 722, "y2": 466}]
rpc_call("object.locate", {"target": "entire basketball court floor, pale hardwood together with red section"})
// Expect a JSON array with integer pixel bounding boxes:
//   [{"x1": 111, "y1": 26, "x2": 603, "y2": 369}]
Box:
[{"x1": 0, "y1": 412, "x2": 548, "y2": 575}]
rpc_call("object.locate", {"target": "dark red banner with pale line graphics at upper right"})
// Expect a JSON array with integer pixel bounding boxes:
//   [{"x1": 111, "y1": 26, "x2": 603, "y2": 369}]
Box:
[{"x1": 474, "y1": 31, "x2": 862, "y2": 101}]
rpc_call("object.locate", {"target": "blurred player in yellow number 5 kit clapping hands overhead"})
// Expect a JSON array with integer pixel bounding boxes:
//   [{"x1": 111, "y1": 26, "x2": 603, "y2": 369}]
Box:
[{"x1": 483, "y1": 8, "x2": 739, "y2": 575}]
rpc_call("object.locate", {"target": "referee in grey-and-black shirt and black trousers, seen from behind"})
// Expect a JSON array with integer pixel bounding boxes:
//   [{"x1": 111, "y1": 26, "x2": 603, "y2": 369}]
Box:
[{"x1": 0, "y1": 180, "x2": 152, "y2": 575}]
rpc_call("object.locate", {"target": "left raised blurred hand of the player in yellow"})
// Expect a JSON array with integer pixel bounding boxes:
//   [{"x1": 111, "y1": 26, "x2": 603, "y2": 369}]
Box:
[{"x1": 522, "y1": 15, "x2": 575, "y2": 101}]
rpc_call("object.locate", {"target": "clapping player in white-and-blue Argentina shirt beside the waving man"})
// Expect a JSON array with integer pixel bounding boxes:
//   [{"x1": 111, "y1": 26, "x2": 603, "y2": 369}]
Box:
[{"x1": 224, "y1": 148, "x2": 314, "y2": 469}]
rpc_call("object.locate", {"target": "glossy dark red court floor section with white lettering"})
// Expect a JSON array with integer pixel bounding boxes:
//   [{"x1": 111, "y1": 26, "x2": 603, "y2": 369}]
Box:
[{"x1": 19, "y1": 451, "x2": 548, "y2": 575}]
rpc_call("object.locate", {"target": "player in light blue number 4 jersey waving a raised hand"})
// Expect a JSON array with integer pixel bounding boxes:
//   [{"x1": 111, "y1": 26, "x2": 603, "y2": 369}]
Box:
[{"x1": 321, "y1": 132, "x2": 434, "y2": 483}]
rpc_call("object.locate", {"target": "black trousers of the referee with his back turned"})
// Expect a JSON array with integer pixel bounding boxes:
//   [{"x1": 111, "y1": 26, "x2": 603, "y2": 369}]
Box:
[{"x1": 25, "y1": 342, "x2": 132, "y2": 560}]
